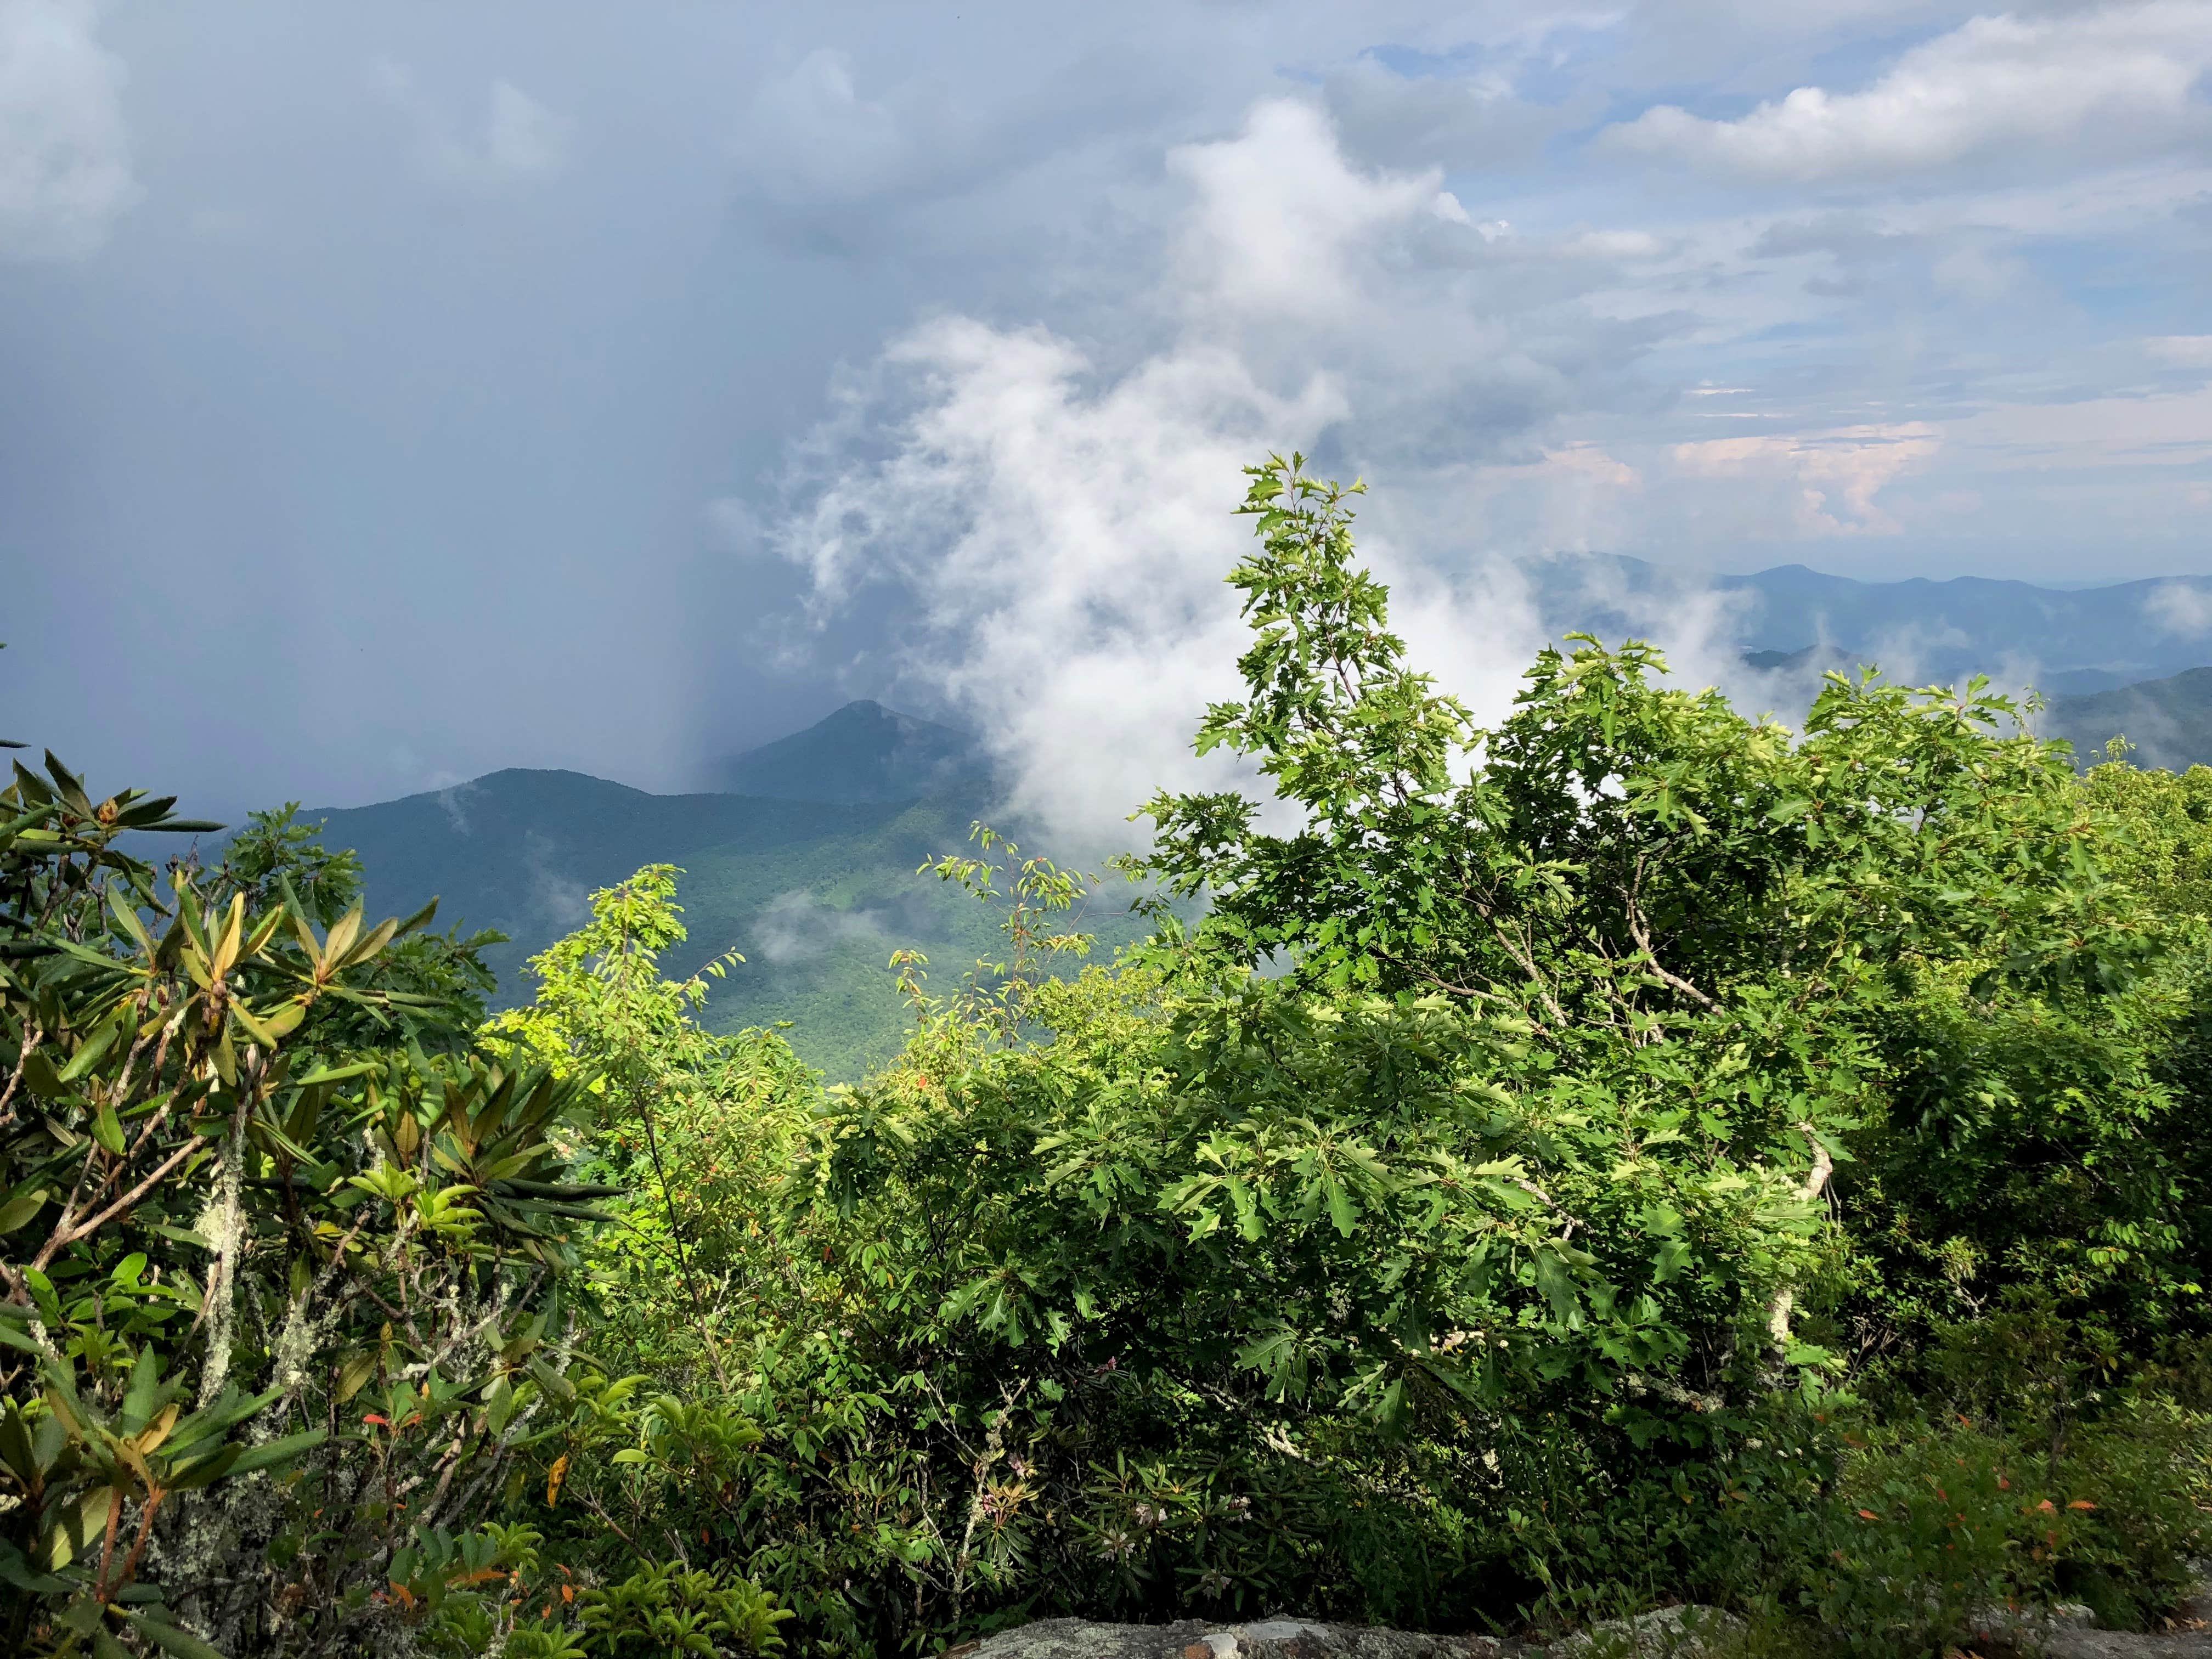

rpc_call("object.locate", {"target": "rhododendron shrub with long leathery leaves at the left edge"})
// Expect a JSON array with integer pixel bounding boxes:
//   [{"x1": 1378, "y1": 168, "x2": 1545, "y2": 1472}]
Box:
[{"x1": 0, "y1": 754, "x2": 597, "y2": 1655}]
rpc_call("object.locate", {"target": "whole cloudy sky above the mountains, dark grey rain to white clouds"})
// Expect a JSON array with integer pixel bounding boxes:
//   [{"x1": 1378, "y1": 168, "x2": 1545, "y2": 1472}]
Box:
[{"x1": 0, "y1": 0, "x2": 2212, "y2": 823}]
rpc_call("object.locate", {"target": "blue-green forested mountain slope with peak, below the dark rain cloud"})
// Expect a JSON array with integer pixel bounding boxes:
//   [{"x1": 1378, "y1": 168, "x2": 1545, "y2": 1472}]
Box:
[{"x1": 303, "y1": 703, "x2": 1132, "y2": 1077}]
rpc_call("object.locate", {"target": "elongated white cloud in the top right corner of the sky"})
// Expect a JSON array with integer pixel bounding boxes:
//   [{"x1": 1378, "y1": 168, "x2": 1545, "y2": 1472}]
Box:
[{"x1": 1606, "y1": 0, "x2": 2212, "y2": 179}]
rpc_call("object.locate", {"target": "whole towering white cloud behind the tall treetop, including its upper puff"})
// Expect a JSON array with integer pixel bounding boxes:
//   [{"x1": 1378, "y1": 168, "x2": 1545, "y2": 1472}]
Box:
[{"x1": 768, "y1": 99, "x2": 1769, "y2": 847}]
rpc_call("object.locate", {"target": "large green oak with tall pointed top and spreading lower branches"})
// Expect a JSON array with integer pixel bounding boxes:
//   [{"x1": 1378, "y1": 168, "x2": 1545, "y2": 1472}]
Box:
[{"x1": 803, "y1": 458, "x2": 2163, "y2": 1617}]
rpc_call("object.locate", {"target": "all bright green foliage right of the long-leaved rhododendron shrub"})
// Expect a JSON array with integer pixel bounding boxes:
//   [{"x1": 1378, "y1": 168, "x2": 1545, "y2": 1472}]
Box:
[{"x1": 479, "y1": 462, "x2": 2203, "y2": 1652}]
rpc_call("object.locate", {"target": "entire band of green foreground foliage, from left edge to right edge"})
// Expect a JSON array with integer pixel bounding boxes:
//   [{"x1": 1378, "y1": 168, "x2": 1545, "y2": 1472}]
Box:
[{"x1": 13, "y1": 456, "x2": 2212, "y2": 1659}]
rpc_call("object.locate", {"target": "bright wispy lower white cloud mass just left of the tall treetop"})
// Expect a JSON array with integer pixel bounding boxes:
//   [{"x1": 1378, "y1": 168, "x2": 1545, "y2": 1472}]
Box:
[{"x1": 776, "y1": 319, "x2": 1340, "y2": 849}]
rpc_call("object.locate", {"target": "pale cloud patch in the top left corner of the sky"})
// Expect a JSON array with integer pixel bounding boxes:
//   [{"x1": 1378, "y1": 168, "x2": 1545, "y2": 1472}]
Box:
[{"x1": 0, "y1": 0, "x2": 139, "y2": 259}]
